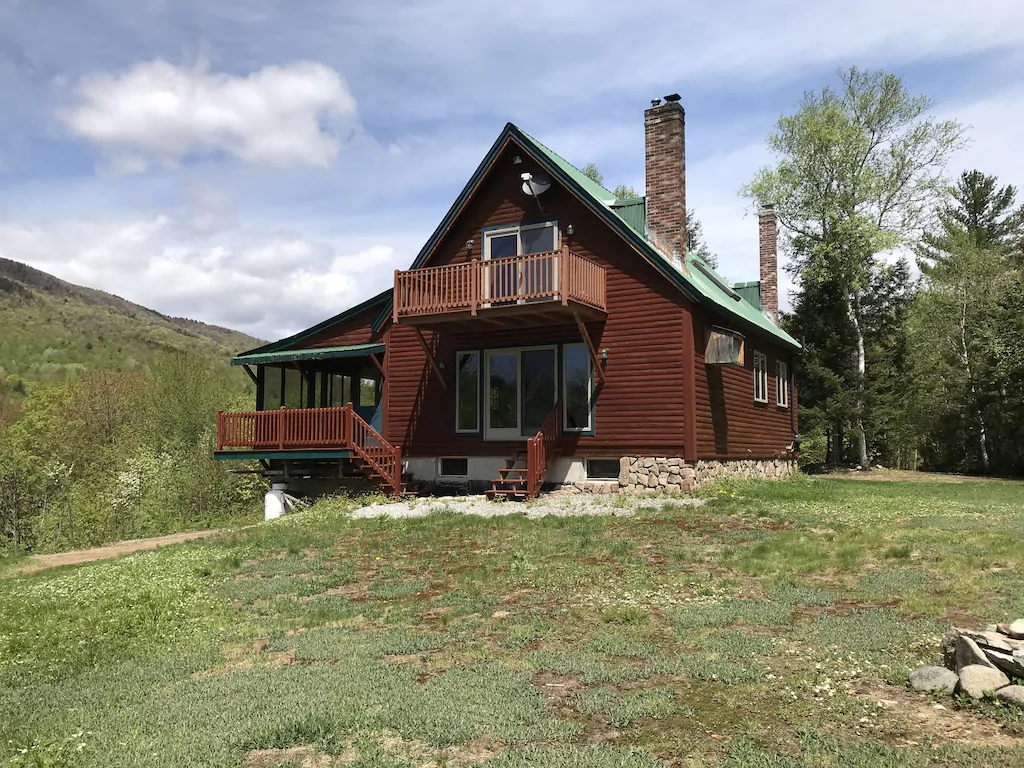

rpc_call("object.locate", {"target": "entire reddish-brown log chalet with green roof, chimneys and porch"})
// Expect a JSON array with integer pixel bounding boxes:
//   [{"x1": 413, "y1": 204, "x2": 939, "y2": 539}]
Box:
[{"x1": 217, "y1": 95, "x2": 800, "y2": 498}]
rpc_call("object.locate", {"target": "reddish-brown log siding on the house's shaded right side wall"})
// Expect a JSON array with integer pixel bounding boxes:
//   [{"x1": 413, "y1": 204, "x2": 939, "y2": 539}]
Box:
[{"x1": 693, "y1": 310, "x2": 796, "y2": 459}]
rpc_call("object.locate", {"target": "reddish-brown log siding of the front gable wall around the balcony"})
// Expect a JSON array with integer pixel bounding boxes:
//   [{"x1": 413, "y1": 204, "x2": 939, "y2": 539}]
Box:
[{"x1": 386, "y1": 145, "x2": 688, "y2": 457}]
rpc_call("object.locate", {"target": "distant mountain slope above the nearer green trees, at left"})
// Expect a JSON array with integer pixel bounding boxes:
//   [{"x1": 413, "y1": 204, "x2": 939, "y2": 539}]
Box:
[{"x1": 0, "y1": 258, "x2": 263, "y2": 389}]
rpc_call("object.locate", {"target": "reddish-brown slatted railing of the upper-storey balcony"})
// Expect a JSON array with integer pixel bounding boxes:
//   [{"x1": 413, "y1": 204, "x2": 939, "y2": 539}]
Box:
[{"x1": 394, "y1": 246, "x2": 607, "y2": 321}]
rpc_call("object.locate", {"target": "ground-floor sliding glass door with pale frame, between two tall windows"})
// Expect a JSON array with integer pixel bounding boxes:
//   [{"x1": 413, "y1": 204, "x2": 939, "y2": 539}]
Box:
[{"x1": 484, "y1": 347, "x2": 558, "y2": 440}]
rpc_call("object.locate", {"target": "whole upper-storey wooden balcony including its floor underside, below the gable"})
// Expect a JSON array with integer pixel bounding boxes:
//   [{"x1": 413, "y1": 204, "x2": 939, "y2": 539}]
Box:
[{"x1": 394, "y1": 247, "x2": 607, "y2": 326}]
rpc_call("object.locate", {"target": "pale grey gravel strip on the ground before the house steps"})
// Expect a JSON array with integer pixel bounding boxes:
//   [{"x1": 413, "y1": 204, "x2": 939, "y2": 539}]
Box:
[{"x1": 351, "y1": 493, "x2": 705, "y2": 519}]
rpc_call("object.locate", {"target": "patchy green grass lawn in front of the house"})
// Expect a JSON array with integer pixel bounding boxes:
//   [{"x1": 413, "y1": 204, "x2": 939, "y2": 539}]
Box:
[{"x1": 0, "y1": 478, "x2": 1024, "y2": 768}]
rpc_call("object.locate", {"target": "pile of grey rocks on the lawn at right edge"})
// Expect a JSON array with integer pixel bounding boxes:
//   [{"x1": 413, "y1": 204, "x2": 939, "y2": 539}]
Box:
[{"x1": 910, "y1": 618, "x2": 1024, "y2": 707}]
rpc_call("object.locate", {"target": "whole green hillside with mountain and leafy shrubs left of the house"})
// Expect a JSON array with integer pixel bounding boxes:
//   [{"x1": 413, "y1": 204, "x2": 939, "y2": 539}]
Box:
[{"x1": 0, "y1": 259, "x2": 262, "y2": 551}]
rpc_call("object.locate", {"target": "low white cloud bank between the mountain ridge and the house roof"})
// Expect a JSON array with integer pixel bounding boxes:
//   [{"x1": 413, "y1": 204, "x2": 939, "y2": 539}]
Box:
[{"x1": 0, "y1": 214, "x2": 412, "y2": 339}]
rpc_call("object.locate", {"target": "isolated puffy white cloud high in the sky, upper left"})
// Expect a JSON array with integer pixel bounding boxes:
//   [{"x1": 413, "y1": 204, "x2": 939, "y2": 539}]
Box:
[{"x1": 56, "y1": 59, "x2": 356, "y2": 173}]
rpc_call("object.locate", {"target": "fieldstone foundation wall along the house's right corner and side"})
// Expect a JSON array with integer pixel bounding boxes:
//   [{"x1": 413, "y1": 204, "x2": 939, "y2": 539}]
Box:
[{"x1": 618, "y1": 456, "x2": 797, "y2": 494}]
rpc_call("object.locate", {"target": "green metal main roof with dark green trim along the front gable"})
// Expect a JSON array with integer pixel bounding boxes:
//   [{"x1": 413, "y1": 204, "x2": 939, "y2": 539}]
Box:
[{"x1": 374, "y1": 123, "x2": 801, "y2": 350}]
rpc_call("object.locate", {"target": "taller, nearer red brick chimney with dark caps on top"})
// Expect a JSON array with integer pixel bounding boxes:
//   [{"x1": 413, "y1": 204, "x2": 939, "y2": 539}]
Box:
[{"x1": 643, "y1": 93, "x2": 686, "y2": 267}]
